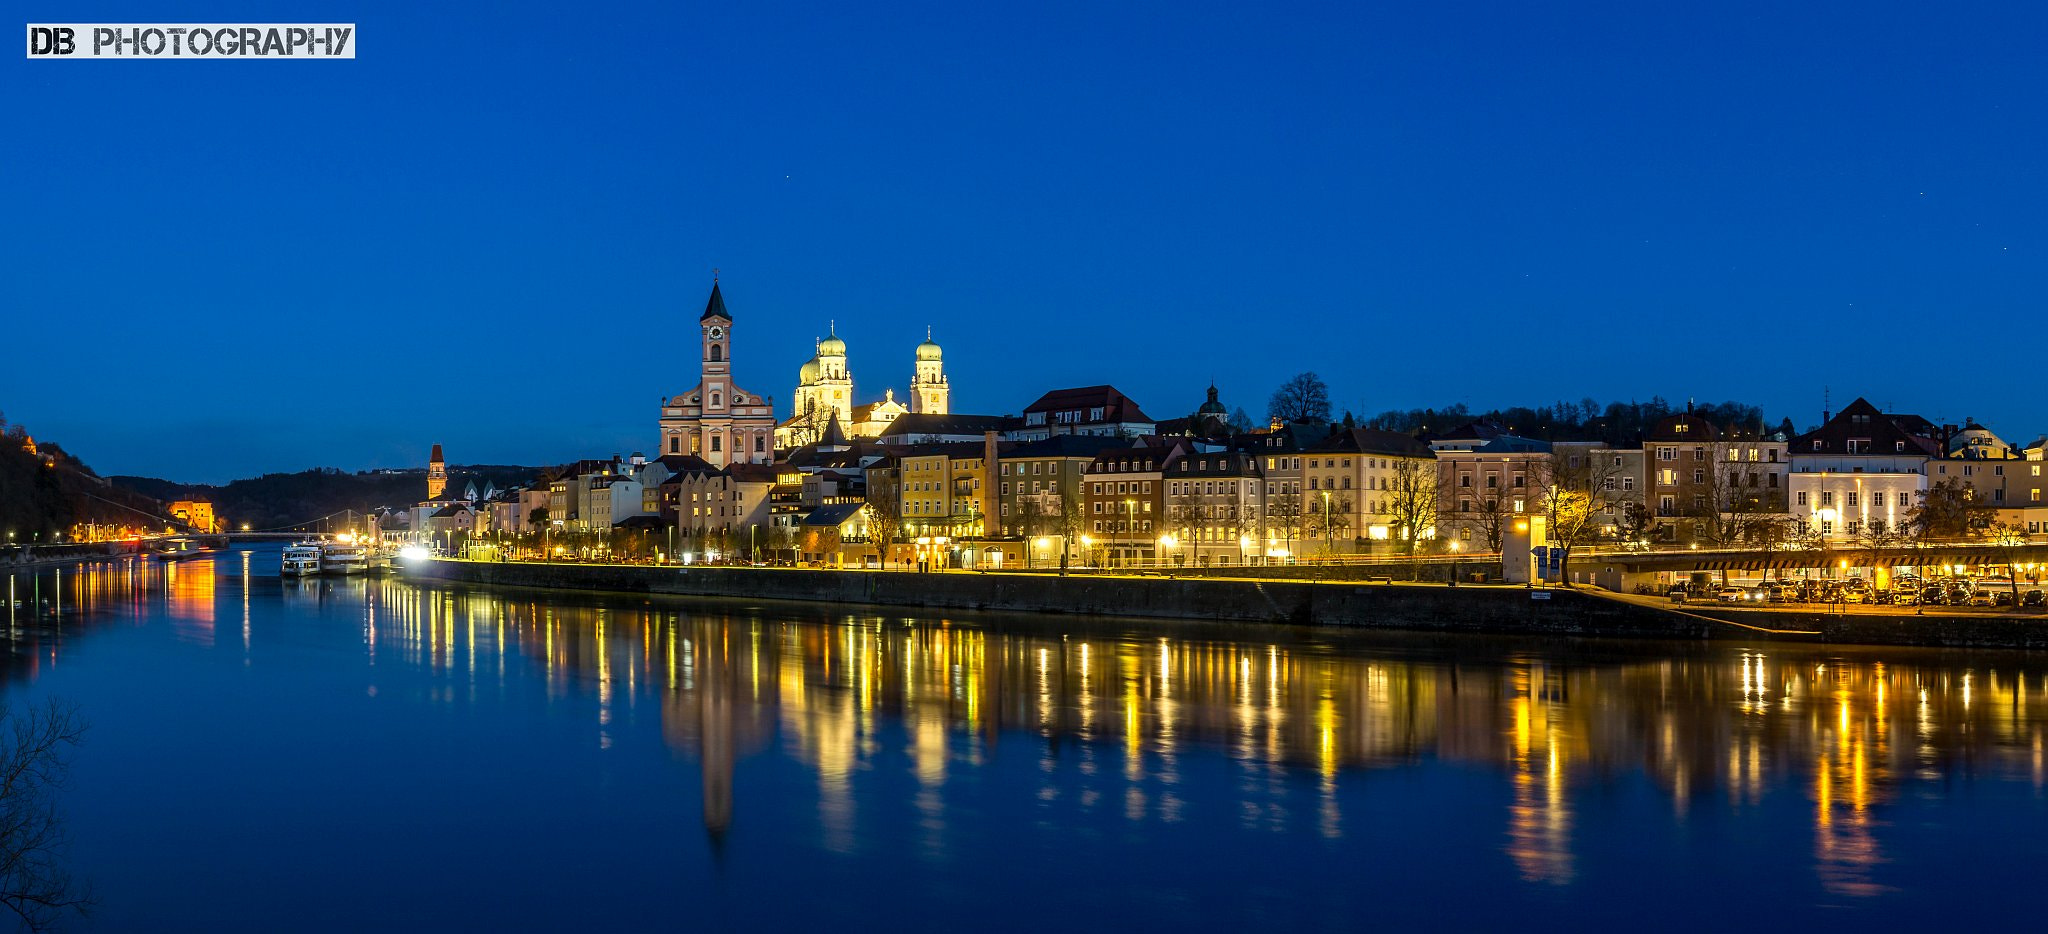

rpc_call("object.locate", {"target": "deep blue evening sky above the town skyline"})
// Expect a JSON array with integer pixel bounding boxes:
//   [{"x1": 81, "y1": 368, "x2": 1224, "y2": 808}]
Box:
[{"x1": 0, "y1": 2, "x2": 2048, "y2": 481}]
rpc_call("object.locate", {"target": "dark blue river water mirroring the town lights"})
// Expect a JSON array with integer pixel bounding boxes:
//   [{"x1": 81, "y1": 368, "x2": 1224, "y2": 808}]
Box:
[{"x1": 6, "y1": 549, "x2": 2048, "y2": 930}]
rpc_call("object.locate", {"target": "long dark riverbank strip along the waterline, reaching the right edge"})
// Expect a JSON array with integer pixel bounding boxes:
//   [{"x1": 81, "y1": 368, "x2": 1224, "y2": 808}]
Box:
[{"x1": 403, "y1": 559, "x2": 2048, "y2": 649}]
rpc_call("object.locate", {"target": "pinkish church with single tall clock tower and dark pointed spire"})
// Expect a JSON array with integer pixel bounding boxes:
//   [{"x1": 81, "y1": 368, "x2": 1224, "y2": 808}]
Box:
[{"x1": 655, "y1": 277, "x2": 776, "y2": 467}]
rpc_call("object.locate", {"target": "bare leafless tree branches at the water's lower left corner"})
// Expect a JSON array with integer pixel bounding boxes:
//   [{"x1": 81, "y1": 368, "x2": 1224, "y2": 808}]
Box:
[{"x1": 0, "y1": 701, "x2": 92, "y2": 930}]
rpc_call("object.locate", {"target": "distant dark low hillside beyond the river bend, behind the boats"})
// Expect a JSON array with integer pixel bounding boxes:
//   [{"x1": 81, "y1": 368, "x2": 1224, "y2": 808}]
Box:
[{"x1": 111, "y1": 465, "x2": 541, "y2": 530}]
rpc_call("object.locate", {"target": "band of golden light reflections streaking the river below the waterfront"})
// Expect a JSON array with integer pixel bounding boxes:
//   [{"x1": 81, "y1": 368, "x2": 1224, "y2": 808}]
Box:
[{"x1": 12, "y1": 555, "x2": 2048, "y2": 925}]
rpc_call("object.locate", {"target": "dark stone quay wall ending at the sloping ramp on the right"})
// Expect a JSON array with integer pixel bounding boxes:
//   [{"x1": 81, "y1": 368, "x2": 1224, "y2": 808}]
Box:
[{"x1": 406, "y1": 559, "x2": 1716, "y2": 639}]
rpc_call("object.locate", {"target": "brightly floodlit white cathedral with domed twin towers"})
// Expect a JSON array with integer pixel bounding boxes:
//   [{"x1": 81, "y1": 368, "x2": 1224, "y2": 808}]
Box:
[{"x1": 774, "y1": 326, "x2": 952, "y2": 451}]
